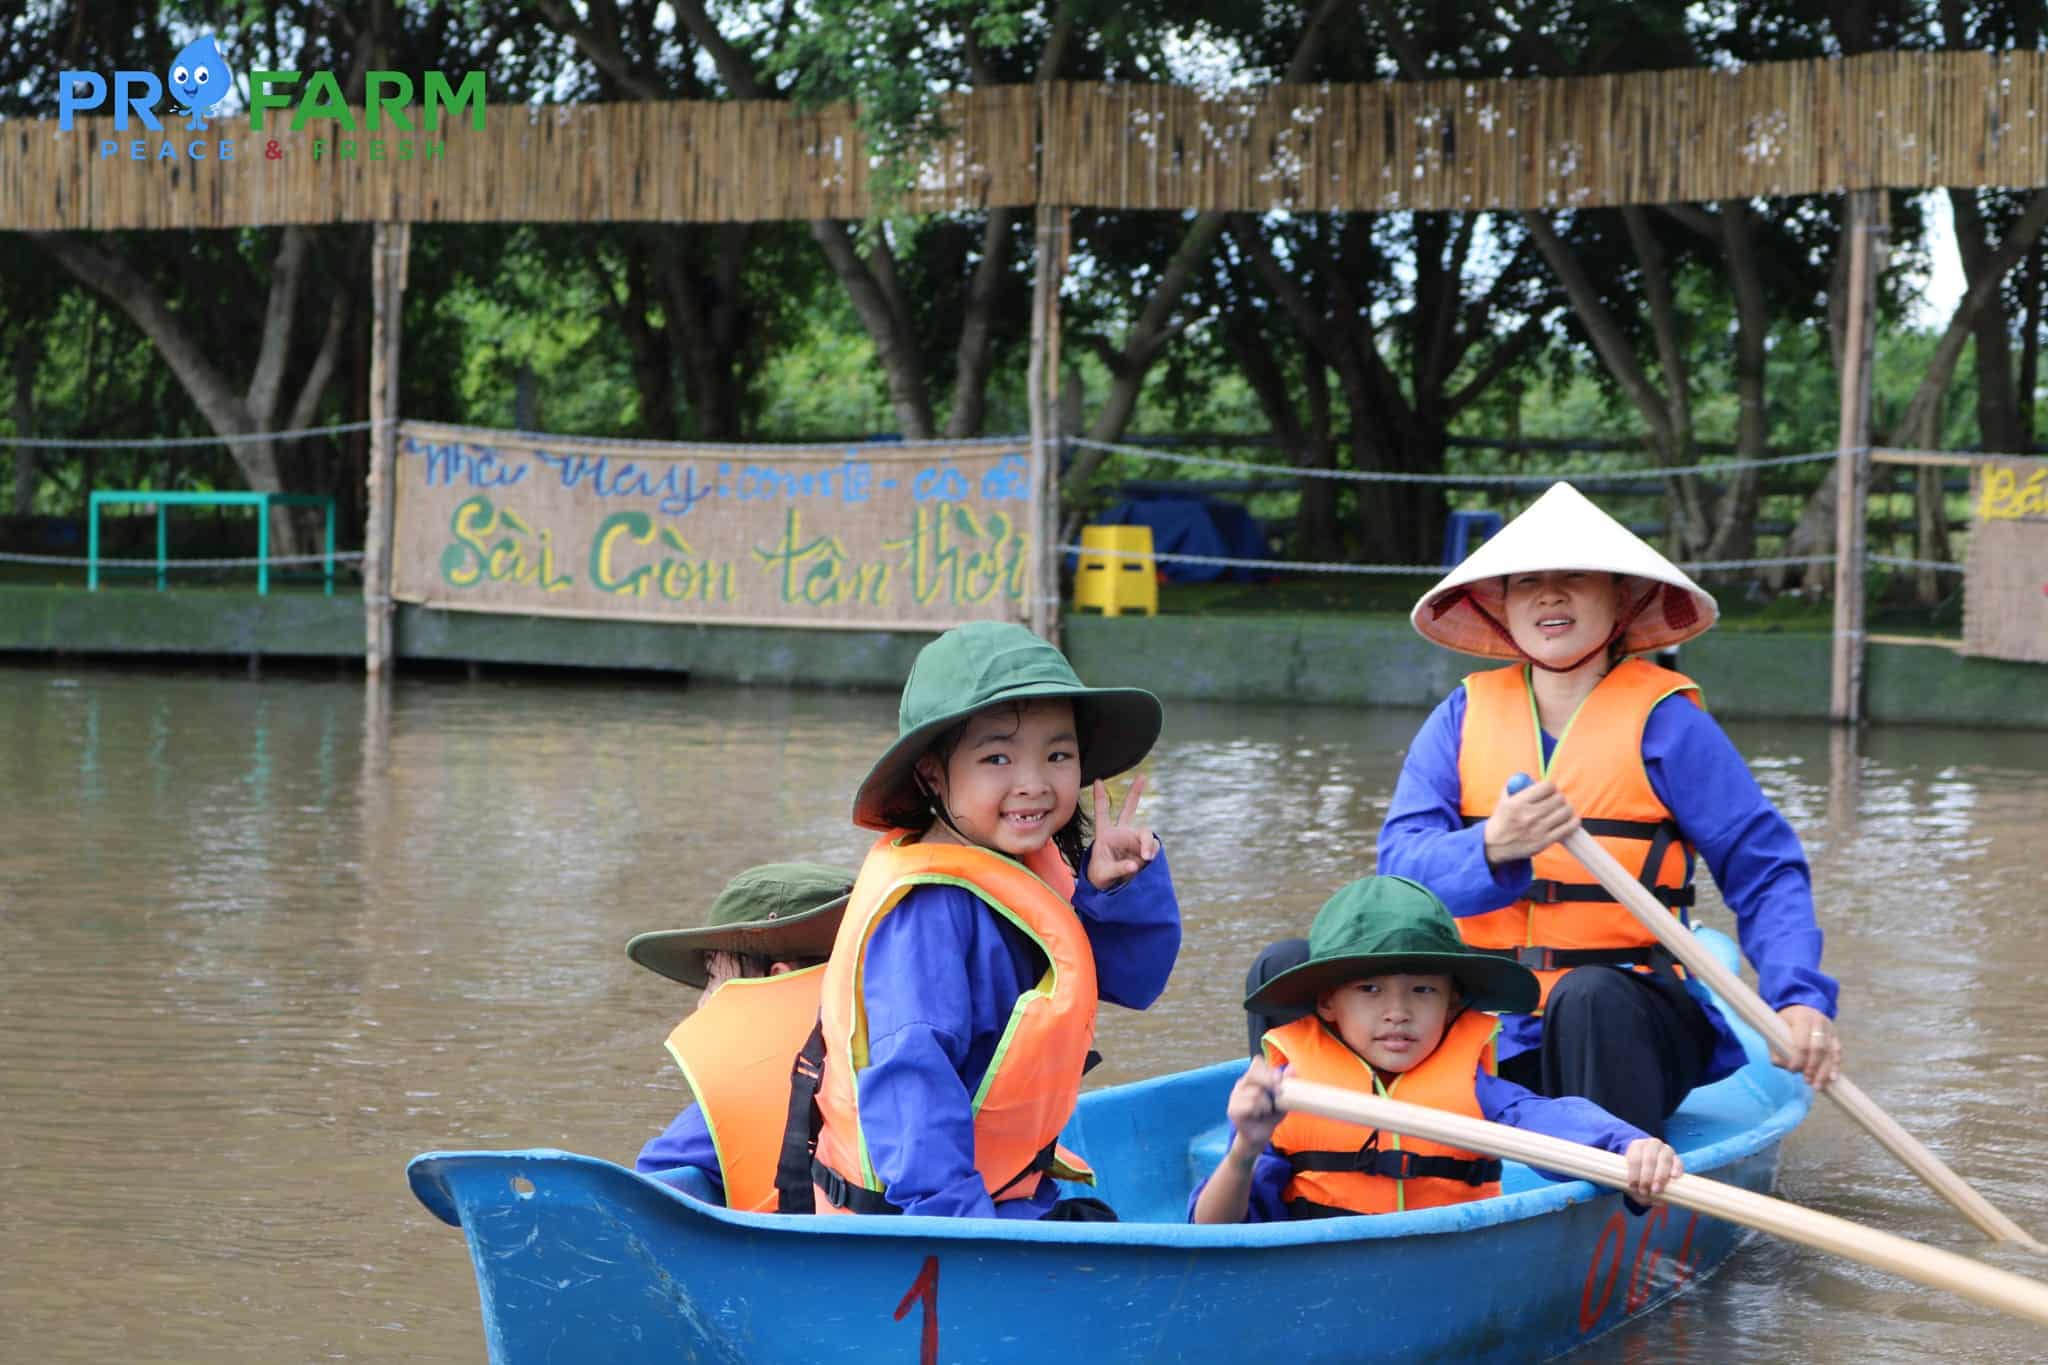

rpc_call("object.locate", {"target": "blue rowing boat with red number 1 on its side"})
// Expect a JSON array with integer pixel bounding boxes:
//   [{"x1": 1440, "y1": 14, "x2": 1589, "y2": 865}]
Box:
[{"x1": 408, "y1": 935, "x2": 1810, "y2": 1365}]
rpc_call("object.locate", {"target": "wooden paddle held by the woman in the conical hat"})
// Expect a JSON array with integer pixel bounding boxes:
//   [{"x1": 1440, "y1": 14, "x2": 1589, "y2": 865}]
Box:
[{"x1": 1507, "y1": 774, "x2": 2048, "y2": 1250}]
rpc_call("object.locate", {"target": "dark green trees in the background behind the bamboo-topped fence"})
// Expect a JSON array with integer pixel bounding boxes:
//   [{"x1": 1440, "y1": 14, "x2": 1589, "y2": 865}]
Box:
[{"x1": 0, "y1": 0, "x2": 2048, "y2": 585}]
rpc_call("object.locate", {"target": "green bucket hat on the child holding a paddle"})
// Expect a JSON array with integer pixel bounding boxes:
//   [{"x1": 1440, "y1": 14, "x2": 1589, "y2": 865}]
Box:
[{"x1": 1245, "y1": 876, "x2": 1536, "y2": 1013}]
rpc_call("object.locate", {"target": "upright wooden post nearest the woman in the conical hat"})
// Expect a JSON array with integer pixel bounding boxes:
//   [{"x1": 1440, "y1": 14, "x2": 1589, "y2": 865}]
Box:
[{"x1": 1827, "y1": 190, "x2": 1888, "y2": 724}]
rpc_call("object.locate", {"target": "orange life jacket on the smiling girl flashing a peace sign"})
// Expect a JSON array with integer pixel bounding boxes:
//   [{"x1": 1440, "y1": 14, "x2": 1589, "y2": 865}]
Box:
[{"x1": 811, "y1": 829, "x2": 1096, "y2": 1214}]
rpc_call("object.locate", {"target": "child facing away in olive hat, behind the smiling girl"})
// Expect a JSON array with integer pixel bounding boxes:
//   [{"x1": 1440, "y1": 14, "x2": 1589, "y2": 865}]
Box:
[{"x1": 627, "y1": 864, "x2": 854, "y2": 1212}]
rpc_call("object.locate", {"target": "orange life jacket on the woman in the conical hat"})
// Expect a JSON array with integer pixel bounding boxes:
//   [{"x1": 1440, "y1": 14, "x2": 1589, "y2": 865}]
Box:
[{"x1": 1458, "y1": 659, "x2": 1704, "y2": 1013}]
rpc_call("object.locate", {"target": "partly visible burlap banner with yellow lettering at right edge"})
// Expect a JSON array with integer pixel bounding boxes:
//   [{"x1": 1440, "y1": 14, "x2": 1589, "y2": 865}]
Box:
[{"x1": 1962, "y1": 460, "x2": 2048, "y2": 663}]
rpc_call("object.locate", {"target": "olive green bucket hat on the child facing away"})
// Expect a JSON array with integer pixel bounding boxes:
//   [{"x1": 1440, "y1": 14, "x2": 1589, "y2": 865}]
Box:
[{"x1": 627, "y1": 864, "x2": 854, "y2": 990}]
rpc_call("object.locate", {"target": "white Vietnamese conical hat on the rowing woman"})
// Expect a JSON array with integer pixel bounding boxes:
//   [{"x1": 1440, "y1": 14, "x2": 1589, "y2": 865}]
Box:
[{"x1": 1409, "y1": 483, "x2": 1720, "y2": 659}]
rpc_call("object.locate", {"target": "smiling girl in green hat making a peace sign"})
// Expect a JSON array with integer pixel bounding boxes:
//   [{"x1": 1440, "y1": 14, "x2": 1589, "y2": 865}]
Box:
[{"x1": 811, "y1": 622, "x2": 1180, "y2": 1220}]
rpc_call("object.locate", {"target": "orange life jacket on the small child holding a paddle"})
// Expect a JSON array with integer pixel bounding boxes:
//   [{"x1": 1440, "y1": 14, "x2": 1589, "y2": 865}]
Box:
[{"x1": 1262, "y1": 1009, "x2": 1501, "y2": 1218}]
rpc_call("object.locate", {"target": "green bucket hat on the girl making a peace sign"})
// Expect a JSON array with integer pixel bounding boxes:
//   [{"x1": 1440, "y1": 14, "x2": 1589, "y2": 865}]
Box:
[{"x1": 854, "y1": 620, "x2": 1163, "y2": 829}]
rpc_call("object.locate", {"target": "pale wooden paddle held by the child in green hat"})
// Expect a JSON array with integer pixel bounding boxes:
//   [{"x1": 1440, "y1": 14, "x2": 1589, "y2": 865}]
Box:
[{"x1": 1276, "y1": 1076, "x2": 2048, "y2": 1326}]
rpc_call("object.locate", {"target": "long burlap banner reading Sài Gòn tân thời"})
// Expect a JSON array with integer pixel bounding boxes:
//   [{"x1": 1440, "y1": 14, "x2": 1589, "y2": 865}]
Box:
[{"x1": 391, "y1": 422, "x2": 1034, "y2": 630}]
